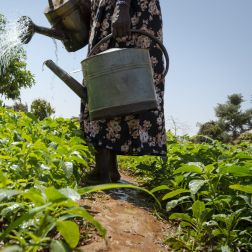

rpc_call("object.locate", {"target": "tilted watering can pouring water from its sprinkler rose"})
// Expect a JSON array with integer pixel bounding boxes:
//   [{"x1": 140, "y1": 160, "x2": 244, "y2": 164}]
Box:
[{"x1": 19, "y1": 0, "x2": 91, "y2": 52}]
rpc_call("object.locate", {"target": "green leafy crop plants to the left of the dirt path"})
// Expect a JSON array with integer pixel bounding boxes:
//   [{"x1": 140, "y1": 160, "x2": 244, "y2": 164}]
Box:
[{"x1": 0, "y1": 108, "x2": 160, "y2": 252}]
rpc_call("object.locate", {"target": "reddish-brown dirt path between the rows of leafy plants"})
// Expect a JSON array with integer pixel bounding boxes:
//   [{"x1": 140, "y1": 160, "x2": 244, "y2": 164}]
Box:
[{"x1": 81, "y1": 174, "x2": 170, "y2": 252}]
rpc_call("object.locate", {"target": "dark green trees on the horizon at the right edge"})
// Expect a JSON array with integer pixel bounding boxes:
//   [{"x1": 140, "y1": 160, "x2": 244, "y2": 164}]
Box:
[{"x1": 198, "y1": 94, "x2": 252, "y2": 142}]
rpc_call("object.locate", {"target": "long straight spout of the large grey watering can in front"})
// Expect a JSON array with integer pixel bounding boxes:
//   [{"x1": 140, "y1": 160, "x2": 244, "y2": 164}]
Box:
[{"x1": 44, "y1": 60, "x2": 87, "y2": 102}]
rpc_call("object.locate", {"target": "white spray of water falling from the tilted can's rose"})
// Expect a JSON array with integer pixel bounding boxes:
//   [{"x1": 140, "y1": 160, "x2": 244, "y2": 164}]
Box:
[{"x1": 0, "y1": 17, "x2": 28, "y2": 74}]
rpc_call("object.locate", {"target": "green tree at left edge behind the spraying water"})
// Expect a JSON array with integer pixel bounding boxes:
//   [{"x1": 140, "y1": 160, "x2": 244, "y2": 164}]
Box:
[{"x1": 0, "y1": 14, "x2": 35, "y2": 99}]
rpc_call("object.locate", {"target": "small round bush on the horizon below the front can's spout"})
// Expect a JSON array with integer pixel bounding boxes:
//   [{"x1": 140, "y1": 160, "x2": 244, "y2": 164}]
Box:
[{"x1": 31, "y1": 99, "x2": 55, "y2": 120}]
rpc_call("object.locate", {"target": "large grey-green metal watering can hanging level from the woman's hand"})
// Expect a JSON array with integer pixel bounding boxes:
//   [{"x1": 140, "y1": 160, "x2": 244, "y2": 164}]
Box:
[{"x1": 45, "y1": 30, "x2": 169, "y2": 121}]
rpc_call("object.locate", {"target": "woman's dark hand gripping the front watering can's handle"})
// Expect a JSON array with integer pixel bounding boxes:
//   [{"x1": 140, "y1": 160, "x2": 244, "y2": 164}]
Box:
[{"x1": 112, "y1": 0, "x2": 131, "y2": 39}]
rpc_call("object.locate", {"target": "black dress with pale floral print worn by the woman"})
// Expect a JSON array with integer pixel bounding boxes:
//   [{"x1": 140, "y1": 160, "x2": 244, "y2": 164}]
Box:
[{"x1": 81, "y1": 0, "x2": 166, "y2": 156}]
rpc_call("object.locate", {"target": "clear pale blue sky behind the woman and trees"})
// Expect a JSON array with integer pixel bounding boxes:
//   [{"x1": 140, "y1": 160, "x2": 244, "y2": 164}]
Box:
[{"x1": 0, "y1": 0, "x2": 252, "y2": 135}]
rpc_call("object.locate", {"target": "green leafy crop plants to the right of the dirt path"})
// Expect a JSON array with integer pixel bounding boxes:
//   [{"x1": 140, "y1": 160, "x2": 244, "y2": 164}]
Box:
[{"x1": 120, "y1": 133, "x2": 252, "y2": 252}]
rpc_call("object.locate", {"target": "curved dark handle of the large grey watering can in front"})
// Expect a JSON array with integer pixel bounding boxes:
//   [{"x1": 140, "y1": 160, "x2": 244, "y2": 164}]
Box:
[{"x1": 88, "y1": 30, "x2": 169, "y2": 76}]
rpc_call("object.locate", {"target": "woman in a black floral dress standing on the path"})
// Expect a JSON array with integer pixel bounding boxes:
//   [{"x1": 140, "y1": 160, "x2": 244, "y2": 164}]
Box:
[{"x1": 81, "y1": 0, "x2": 166, "y2": 183}]
